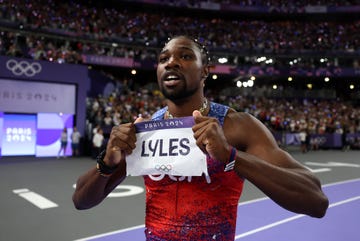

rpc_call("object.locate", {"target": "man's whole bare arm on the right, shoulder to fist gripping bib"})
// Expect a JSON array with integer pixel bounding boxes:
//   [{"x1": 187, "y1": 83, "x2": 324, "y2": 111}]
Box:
[{"x1": 195, "y1": 111, "x2": 328, "y2": 217}]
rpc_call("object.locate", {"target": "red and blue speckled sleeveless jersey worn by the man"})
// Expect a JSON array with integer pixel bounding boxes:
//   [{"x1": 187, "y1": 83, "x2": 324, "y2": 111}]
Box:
[{"x1": 144, "y1": 102, "x2": 244, "y2": 241}]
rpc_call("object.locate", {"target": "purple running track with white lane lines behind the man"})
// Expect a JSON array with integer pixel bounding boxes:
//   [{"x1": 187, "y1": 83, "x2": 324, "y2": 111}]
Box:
[{"x1": 78, "y1": 179, "x2": 360, "y2": 241}]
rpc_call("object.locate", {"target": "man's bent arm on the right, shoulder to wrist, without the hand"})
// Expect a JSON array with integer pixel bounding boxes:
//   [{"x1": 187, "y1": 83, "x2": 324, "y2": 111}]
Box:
[{"x1": 234, "y1": 112, "x2": 329, "y2": 217}]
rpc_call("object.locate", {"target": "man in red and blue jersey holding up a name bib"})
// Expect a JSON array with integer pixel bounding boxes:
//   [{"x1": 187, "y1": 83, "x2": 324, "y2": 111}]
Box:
[{"x1": 73, "y1": 36, "x2": 328, "y2": 240}]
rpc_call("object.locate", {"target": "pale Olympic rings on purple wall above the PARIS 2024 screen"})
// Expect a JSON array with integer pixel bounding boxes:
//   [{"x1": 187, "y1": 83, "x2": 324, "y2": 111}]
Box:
[{"x1": 6, "y1": 59, "x2": 42, "y2": 77}]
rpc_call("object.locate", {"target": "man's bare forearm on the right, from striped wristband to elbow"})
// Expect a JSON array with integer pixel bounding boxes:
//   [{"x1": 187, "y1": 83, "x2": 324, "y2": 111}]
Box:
[{"x1": 235, "y1": 144, "x2": 328, "y2": 218}]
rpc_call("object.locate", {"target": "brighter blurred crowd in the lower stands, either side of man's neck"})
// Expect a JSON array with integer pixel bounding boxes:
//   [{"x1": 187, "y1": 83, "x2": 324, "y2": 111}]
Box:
[{"x1": 87, "y1": 84, "x2": 360, "y2": 138}]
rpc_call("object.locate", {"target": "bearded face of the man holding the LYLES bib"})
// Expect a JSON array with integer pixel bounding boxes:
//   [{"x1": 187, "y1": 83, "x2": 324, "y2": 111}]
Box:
[{"x1": 157, "y1": 38, "x2": 206, "y2": 100}]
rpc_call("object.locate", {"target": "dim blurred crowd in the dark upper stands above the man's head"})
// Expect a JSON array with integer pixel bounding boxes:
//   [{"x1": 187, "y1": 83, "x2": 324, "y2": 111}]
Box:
[{"x1": 0, "y1": 0, "x2": 360, "y2": 68}]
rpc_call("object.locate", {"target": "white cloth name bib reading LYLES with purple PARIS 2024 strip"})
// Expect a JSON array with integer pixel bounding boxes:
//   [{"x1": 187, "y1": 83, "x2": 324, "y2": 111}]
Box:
[{"x1": 126, "y1": 116, "x2": 208, "y2": 176}]
